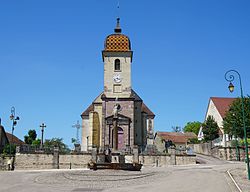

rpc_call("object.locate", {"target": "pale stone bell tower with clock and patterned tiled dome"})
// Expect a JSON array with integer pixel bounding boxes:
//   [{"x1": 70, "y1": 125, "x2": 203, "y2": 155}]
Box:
[{"x1": 102, "y1": 18, "x2": 133, "y2": 98}]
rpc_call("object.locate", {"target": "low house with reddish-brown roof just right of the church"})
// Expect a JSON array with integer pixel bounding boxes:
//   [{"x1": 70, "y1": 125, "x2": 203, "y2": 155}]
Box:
[{"x1": 154, "y1": 132, "x2": 197, "y2": 152}]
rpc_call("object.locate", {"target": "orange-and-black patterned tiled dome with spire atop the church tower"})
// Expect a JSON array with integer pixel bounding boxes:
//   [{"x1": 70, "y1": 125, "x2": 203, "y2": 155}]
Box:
[{"x1": 104, "y1": 18, "x2": 131, "y2": 52}]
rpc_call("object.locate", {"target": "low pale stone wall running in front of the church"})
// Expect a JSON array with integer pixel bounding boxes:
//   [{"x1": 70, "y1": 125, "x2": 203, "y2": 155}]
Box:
[{"x1": 15, "y1": 154, "x2": 196, "y2": 170}]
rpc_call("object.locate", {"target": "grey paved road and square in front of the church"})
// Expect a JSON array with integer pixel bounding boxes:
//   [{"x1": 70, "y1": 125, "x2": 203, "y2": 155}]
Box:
[{"x1": 0, "y1": 156, "x2": 246, "y2": 192}]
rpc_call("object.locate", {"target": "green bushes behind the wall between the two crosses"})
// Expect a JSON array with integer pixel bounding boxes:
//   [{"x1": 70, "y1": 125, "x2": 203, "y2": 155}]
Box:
[{"x1": 44, "y1": 138, "x2": 70, "y2": 153}]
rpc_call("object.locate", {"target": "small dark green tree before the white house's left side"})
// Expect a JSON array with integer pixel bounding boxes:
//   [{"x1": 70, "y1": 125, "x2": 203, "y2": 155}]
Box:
[{"x1": 202, "y1": 115, "x2": 219, "y2": 141}]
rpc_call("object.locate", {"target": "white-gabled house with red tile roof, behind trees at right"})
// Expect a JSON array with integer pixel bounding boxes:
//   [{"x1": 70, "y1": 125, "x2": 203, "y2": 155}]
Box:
[{"x1": 198, "y1": 97, "x2": 236, "y2": 146}]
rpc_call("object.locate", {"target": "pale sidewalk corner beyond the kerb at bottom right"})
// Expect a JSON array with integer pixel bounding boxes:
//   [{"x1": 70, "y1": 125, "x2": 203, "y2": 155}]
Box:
[{"x1": 230, "y1": 168, "x2": 250, "y2": 192}]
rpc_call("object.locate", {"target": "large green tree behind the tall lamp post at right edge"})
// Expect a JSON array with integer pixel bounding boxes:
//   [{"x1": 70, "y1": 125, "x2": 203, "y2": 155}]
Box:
[{"x1": 223, "y1": 98, "x2": 250, "y2": 138}]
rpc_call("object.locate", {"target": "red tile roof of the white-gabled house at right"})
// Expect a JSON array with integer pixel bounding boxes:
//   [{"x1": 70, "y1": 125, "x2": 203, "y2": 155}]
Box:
[{"x1": 210, "y1": 97, "x2": 236, "y2": 118}]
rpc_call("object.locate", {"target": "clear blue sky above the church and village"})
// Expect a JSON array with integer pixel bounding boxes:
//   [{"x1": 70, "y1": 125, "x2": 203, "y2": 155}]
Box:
[{"x1": 0, "y1": 0, "x2": 250, "y2": 147}]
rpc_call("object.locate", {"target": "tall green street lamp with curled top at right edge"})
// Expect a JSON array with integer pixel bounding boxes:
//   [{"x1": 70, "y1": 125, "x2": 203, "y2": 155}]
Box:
[{"x1": 225, "y1": 70, "x2": 250, "y2": 180}]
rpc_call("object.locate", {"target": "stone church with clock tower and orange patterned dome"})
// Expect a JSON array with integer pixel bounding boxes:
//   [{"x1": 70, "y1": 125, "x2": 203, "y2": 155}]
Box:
[{"x1": 81, "y1": 18, "x2": 155, "y2": 152}]
